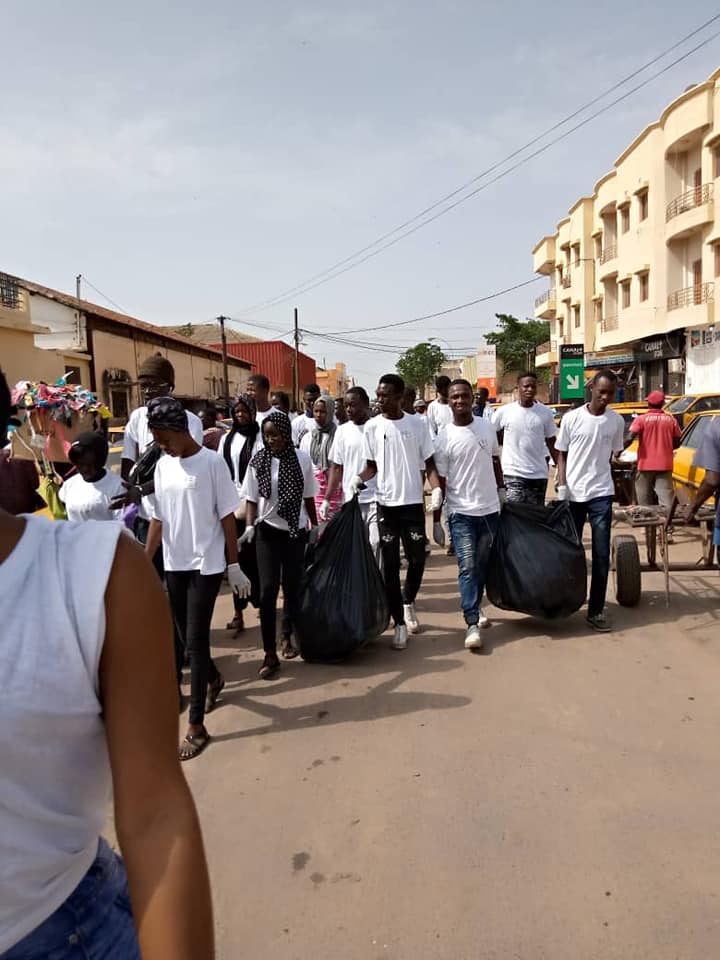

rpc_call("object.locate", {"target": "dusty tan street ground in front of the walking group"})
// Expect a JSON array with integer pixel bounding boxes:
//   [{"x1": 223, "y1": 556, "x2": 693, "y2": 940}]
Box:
[{"x1": 181, "y1": 524, "x2": 720, "y2": 960}]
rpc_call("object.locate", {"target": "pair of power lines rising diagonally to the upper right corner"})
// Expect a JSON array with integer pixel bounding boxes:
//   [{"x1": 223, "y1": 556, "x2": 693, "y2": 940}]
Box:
[{"x1": 233, "y1": 13, "x2": 720, "y2": 313}]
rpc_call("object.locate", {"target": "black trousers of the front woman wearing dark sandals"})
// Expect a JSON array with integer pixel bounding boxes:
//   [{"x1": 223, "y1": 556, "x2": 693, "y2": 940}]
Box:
[{"x1": 165, "y1": 570, "x2": 222, "y2": 723}]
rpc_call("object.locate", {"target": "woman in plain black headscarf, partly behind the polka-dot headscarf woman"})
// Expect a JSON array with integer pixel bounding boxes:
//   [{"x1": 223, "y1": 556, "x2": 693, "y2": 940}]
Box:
[{"x1": 218, "y1": 393, "x2": 263, "y2": 633}]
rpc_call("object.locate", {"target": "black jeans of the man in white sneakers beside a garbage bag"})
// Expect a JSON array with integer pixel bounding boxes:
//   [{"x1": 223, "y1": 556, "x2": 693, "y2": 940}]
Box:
[{"x1": 378, "y1": 503, "x2": 425, "y2": 626}]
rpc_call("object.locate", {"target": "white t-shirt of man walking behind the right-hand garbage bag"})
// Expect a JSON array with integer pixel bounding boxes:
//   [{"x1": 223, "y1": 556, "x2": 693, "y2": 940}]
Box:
[{"x1": 486, "y1": 400, "x2": 557, "y2": 480}]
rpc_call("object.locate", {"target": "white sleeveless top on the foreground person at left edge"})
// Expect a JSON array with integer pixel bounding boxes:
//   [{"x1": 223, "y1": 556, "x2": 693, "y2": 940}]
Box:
[{"x1": 0, "y1": 517, "x2": 121, "y2": 954}]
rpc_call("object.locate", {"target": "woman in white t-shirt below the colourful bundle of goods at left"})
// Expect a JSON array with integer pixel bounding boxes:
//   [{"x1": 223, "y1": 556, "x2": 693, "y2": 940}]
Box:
[{"x1": 58, "y1": 431, "x2": 125, "y2": 522}]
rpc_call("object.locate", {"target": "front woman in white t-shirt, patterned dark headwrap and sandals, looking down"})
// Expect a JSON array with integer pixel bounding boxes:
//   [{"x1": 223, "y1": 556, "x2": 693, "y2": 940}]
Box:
[{"x1": 145, "y1": 397, "x2": 250, "y2": 760}]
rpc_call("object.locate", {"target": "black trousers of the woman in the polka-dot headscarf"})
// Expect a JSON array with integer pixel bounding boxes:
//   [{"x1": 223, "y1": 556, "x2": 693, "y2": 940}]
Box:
[{"x1": 255, "y1": 523, "x2": 307, "y2": 653}]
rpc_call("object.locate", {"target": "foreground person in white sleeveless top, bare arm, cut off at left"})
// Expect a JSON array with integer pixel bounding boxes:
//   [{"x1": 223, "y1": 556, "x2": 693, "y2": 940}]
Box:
[{"x1": 0, "y1": 373, "x2": 214, "y2": 960}]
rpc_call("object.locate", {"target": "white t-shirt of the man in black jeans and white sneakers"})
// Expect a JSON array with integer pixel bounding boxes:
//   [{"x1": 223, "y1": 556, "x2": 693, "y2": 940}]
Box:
[{"x1": 363, "y1": 414, "x2": 434, "y2": 507}]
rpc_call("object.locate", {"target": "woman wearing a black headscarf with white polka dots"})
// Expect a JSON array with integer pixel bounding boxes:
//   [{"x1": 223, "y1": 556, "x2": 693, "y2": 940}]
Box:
[{"x1": 239, "y1": 410, "x2": 317, "y2": 680}]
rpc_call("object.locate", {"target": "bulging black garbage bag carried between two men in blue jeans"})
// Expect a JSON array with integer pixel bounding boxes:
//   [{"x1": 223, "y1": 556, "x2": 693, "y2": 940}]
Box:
[{"x1": 487, "y1": 502, "x2": 587, "y2": 619}]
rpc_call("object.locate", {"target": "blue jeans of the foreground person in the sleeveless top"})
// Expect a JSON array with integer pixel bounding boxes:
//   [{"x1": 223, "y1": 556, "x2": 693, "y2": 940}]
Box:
[{"x1": 0, "y1": 840, "x2": 140, "y2": 960}]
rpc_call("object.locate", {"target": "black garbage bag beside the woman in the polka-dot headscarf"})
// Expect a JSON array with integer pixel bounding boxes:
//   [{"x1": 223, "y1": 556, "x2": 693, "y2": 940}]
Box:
[{"x1": 293, "y1": 497, "x2": 388, "y2": 662}]
